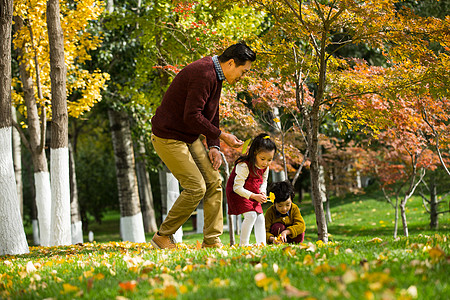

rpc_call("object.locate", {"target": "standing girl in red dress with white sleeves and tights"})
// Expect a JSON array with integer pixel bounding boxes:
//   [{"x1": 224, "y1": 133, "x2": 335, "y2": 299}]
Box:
[{"x1": 226, "y1": 133, "x2": 277, "y2": 246}]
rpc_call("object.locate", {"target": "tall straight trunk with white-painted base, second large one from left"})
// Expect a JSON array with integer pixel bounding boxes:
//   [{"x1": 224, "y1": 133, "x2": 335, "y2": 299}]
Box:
[{"x1": 47, "y1": 0, "x2": 72, "y2": 246}]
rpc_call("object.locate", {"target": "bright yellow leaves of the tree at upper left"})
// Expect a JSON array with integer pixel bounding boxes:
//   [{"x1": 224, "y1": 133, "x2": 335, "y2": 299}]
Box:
[{"x1": 12, "y1": 0, "x2": 109, "y2": 118}]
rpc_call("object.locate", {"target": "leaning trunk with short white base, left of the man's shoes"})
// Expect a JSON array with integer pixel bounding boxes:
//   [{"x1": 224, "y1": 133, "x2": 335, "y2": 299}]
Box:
[{"x1": 108, "y1": 109, "x2": 145, "y2": 243}]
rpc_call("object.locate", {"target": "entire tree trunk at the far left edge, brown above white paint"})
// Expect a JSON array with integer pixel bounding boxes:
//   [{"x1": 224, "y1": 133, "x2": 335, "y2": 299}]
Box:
[{"x1": 0, "y1": 0, "x2": 29, "y2": 255}]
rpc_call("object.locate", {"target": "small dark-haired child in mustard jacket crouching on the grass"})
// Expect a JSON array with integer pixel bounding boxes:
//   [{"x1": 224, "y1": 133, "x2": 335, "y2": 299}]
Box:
[{"x1": 265, "y1": 181, "x2": 305, "y2": 244}]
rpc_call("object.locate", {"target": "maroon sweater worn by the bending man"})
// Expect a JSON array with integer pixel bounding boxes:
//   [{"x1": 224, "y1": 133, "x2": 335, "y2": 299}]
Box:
[{"x1": 152, "y1": 56, "x2": 222, "y2": 147}]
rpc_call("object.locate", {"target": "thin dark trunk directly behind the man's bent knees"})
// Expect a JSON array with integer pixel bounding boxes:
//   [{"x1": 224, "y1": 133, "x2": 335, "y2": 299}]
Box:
[{"x1": 136, "y1": 140, "x2": 158, "y2": 232}]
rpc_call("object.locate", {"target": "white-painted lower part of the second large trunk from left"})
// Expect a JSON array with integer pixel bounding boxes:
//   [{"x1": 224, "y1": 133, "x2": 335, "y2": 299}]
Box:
[{"x1": 50, "y1": 148, "x2": 72, "y2": 246}]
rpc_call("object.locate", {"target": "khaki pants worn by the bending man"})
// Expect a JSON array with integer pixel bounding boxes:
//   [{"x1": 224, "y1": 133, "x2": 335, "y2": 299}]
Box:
[{"x1": 152, "y1": 135, "x2": 223, "y2": 244}]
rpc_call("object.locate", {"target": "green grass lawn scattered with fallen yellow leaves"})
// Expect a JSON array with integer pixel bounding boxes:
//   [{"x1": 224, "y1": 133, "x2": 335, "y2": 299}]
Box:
[{"x1": 0, "y1": 191, "x2": 450, "y2": 300}]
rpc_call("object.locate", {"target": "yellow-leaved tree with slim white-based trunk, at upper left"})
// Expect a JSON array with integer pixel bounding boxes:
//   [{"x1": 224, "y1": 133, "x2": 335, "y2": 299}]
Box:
[{"x1": 13, "y1": 0, "x2": 108, "y2": 246}]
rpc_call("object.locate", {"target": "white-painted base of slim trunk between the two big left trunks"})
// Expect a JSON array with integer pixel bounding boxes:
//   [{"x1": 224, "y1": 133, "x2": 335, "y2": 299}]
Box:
[{"x1": 34, "y1": 172, "x2": 52, "y2": 247}]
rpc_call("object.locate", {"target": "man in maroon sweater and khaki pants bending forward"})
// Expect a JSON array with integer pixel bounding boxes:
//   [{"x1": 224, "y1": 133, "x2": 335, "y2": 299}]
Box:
[{"x1": 151, "y1": 42, "x2": 256, "y2": 249}]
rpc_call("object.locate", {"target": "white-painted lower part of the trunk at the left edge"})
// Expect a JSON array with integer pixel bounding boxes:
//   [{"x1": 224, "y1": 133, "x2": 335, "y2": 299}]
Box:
[{"x1": 0, "y1": 127, "x2": 29, "y2": 255}]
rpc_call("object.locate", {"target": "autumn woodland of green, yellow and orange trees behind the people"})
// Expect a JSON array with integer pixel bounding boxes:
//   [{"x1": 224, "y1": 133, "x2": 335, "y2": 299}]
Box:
[{"x1": 0, "y1": 0, "x2": 450, "y2": 255}]
